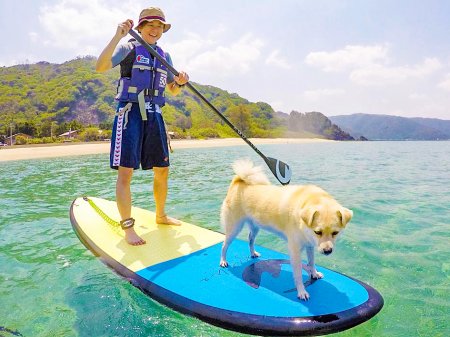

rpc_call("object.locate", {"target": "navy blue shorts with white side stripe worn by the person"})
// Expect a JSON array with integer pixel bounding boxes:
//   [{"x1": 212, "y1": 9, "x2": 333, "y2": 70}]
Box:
[{"x1": 110, "y1": 102, "x2": 170, "y2": 170}]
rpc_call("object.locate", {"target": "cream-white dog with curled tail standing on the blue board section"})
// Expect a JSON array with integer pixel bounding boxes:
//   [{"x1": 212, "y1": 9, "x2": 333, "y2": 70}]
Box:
[{"x1": 220, "y1": 160, "x2": 353, "y2": 300}]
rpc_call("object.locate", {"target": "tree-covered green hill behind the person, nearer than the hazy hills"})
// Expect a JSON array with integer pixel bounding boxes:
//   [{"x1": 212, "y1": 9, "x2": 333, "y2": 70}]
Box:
[{"x1": 0, "y1": 57, "x2": 352, "y2": 141}]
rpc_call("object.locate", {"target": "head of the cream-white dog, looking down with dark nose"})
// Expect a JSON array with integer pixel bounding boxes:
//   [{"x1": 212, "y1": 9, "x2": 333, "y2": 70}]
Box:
[{"x1": 301, "y1": 206, "x2": 353, "y2": 255}]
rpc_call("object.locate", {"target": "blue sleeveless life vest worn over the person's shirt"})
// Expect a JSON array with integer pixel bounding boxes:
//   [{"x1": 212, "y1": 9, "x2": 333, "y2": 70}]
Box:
[{"x1": 116, "y1": 42, "x2": 167, "y2": 107}]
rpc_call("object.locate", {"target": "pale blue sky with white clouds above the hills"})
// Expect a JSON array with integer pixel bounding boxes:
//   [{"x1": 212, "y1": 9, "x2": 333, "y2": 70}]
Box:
[{"x1": 0, "y1": 0, "x2": 450, "y2": 120}]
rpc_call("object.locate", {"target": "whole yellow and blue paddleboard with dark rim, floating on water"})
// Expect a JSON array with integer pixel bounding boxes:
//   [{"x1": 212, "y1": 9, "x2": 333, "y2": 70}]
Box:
[{"x1": 70, "y1": 197, "x2": 383, "y2": 336}]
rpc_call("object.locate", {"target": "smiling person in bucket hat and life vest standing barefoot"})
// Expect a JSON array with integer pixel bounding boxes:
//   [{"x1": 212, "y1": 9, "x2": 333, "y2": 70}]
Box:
[{"x1": 96, "y1": 7, "x2": 189, "y2": 245}]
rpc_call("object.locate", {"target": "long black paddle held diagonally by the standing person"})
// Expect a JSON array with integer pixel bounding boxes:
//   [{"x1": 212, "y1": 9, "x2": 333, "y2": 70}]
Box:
[{"x1": 128, "y1": 29, "x2": 292, "y2": 185}]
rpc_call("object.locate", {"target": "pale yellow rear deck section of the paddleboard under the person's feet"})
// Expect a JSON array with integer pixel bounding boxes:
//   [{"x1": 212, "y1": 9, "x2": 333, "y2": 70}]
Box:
[{"x1": 73, "y1": 197, "x2": 224, "y2": 272}]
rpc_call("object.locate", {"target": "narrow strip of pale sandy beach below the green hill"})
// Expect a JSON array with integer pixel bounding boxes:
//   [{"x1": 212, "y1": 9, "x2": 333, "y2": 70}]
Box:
[{"x1": 0, "y1": 138, "x2": 331, "y2": 162}]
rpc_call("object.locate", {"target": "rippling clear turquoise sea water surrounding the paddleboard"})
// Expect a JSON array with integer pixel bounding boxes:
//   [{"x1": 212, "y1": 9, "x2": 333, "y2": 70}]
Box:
[{"x1": 0, "y1": 142, "x2": 450, "y2": 337}]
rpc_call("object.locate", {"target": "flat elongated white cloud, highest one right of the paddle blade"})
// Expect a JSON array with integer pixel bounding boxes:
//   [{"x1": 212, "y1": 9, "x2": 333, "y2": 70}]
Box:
[{"x1": 305, "y1": 45, "x2": 388, "y2": 72}]
